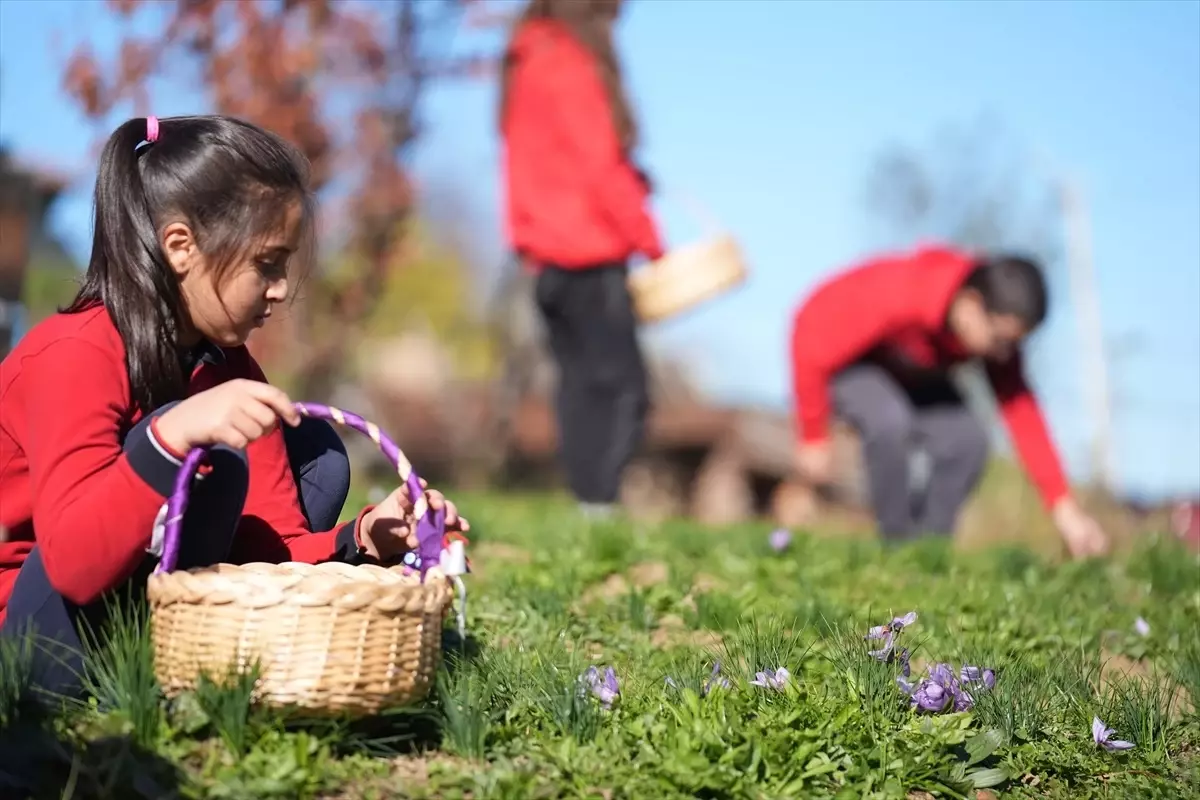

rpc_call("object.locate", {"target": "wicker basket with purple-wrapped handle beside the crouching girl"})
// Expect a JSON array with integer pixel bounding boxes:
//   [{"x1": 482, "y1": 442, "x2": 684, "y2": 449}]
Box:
[{"x1": 148, "y1": 403, "x2": 462, "y2": 715}]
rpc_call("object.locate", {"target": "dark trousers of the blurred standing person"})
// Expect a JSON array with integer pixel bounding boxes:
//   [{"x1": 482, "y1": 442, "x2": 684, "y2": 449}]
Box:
[{"x1": 536, "y1": 264, "x2": 649, "y2": 504}]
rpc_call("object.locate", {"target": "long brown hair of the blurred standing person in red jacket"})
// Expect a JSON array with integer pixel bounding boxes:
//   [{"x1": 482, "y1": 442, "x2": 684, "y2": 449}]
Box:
[{"x1": 499, "y1": 0, "x2": 637, "y2": 154}]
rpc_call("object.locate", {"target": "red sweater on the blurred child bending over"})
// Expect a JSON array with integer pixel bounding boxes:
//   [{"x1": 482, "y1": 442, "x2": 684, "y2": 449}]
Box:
[{"x1": 792, "y1": 248, "x2": 1067, "y2": 507}]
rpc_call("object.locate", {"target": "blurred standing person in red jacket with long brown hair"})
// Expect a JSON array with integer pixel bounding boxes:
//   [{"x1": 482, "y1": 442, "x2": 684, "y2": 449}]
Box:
[{"x1": 499, "y1": 0, "x2": 662, "y2": 515}]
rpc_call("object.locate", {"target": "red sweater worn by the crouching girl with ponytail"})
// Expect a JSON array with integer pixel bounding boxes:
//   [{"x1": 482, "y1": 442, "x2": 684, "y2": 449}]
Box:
[{"x1": 0, "y1": 303, "x2": 356, "y2": 622}]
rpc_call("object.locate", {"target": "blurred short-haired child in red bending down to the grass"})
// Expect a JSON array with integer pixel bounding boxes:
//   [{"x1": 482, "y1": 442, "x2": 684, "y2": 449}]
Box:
[{"x1": 792, "y1": 247, "x2": 1108, "y2": 557}]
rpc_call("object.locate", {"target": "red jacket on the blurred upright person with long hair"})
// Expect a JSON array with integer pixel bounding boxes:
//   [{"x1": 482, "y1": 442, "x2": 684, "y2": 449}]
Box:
[{"x1": 503, "y1": 22, "x2": 662, "y2": 267}]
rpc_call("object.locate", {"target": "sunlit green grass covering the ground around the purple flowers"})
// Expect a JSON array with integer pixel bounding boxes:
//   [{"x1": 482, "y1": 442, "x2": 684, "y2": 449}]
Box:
[{"x1": 0, "y1": 495, "x2": 1200, "y2": 800}]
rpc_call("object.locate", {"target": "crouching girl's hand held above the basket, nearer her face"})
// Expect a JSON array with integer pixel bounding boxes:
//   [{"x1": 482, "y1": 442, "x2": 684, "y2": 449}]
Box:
[{"x1": 154, "y1": 379, "x2": 300, "y2": 453}]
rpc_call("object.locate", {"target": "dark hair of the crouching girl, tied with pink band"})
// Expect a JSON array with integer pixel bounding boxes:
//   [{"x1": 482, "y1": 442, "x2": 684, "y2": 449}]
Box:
[{"x1": 62, "y1": 116, "x2": 312, "y2": 411}]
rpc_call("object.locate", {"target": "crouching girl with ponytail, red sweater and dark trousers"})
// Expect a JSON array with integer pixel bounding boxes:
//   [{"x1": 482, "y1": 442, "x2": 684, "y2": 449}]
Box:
[{"x1": 0, "y1": 116, "x2": 467, "y2": 692}]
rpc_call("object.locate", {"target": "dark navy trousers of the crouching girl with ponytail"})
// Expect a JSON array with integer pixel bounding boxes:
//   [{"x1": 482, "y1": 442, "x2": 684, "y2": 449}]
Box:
[{"x1": 0, "y1": 405, "x2": 350, "y2": 697}]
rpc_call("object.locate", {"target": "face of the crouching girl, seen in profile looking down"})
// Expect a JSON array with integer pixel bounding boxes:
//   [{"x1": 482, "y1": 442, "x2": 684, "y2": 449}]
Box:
[{"x1": 162, "y1": 203, "x2": 302, "y2": 348}]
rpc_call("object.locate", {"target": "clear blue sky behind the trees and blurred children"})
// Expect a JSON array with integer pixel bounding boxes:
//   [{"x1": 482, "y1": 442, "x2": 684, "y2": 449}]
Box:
[{"x1": 0, "y1": 0, "x2": 1200, "y2": 494}]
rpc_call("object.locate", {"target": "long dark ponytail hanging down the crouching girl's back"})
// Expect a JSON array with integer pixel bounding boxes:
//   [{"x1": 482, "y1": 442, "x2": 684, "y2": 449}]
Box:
[{"x1": 64, "y1": 118, "x2": 184, "y2": 413}]
